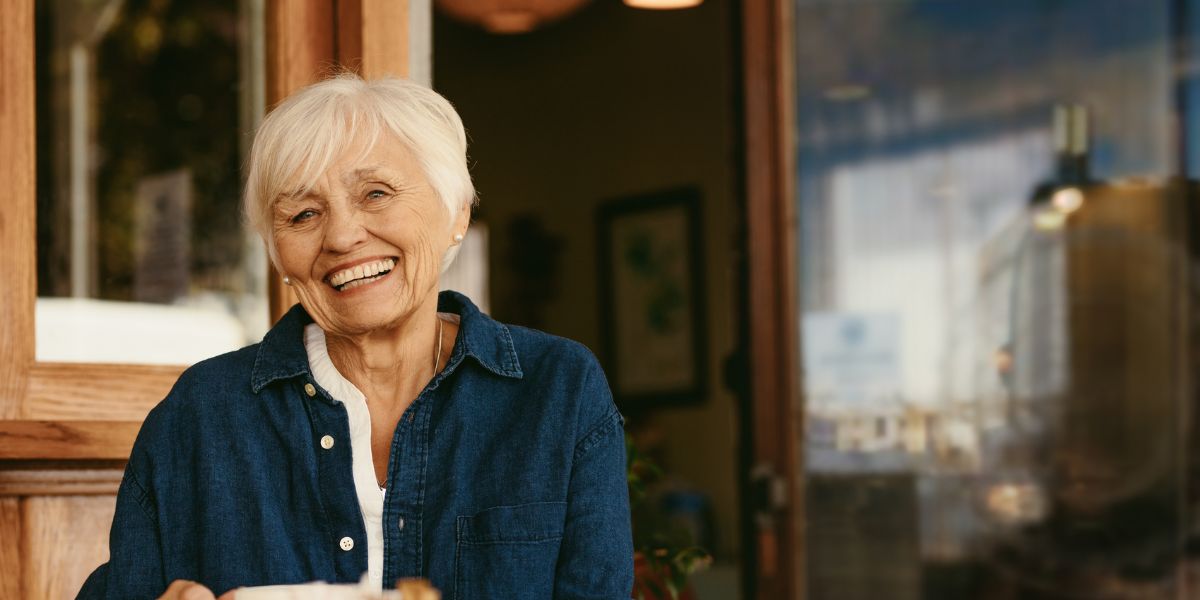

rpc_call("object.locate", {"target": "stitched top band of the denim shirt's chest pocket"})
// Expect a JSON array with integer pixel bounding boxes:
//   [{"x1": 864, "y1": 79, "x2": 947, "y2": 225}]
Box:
[{"x1": 456, "y1": 502, "x2": 566, "y2": 544}]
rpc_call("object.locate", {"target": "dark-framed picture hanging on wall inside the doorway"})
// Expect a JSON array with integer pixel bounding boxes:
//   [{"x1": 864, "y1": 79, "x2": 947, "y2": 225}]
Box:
[{"x1": 596, "y1": 187, "x2": 707, "y2": 412}]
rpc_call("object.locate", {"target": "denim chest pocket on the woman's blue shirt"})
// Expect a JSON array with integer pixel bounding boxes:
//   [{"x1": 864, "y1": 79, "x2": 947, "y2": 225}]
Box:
[{"x1": 454, "y1": 502, "x2": 566, "y2": 600}]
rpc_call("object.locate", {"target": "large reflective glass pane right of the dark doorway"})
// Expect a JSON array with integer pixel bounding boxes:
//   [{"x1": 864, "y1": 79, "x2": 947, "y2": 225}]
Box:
[{"x1": 792, "y1": 0, "x2": 1200, "y2": 600}]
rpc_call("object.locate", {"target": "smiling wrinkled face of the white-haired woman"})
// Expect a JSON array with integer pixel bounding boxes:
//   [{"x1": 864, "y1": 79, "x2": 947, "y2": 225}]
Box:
[{"x1": 272, "y1": 137, "x2": 469, "y2": 335}]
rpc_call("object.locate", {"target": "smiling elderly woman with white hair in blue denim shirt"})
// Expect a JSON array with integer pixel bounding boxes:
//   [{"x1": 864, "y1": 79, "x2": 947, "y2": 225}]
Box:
[{"x1": 80, "y1": 76, "x2": 632, "y2": 599}]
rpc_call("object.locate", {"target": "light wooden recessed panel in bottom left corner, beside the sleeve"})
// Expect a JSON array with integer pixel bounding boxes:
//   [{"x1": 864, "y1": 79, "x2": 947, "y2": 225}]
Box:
[{"x1": 20, "y1": 496, "x2": 116, "y2": 598}]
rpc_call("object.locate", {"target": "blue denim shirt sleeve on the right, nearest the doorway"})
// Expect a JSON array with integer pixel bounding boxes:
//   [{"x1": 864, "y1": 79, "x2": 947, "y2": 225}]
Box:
[{"x1": 554, "y1": 366, "x2": 634, "y2": 600}]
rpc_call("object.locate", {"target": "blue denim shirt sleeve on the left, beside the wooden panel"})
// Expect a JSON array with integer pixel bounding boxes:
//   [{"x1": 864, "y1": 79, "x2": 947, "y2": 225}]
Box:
[{"x1": 77, "y1": 451, "x2": 167, "y2": 600}]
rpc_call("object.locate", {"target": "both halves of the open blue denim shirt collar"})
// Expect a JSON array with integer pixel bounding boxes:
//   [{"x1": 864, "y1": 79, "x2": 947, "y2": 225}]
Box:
[{"x1": 251, "y1": 290, "x2": 524, "y2": 394}]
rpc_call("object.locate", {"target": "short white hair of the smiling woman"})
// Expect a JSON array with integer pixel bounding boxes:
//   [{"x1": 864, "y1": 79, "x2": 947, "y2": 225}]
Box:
[{"x1": 242, "y1": 73, "x2": 476, "y2": 271}]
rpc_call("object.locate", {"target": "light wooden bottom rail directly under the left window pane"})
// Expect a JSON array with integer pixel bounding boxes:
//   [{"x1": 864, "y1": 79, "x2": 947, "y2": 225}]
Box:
[{"x1": 22, "y1": 362, "x2": 184, "y2": 421}]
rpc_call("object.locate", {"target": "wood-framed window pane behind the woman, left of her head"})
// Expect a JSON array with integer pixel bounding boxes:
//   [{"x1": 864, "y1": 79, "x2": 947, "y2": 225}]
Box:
[{"x1": 36, "y1": 0, "x2": 268, "y2": 364}]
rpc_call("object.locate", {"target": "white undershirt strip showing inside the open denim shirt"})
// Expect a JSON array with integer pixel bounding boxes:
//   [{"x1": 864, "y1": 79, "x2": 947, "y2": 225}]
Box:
[{"x1": 304, "y1": 323, "x2": 385, "y2": 589}]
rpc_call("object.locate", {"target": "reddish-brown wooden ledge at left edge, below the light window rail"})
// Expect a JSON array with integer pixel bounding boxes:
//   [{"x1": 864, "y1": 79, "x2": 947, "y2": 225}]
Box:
[{"x1": 0, "y1": 421, "x2": 142, "y2": 461}]
